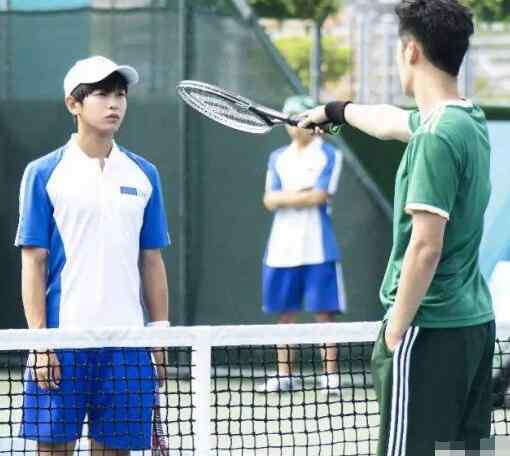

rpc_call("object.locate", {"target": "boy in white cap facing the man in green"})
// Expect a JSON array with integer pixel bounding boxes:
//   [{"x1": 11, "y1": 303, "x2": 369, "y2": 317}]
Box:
[{"x1": 15, "y1": 56, "x2": 169, "y2": 455}]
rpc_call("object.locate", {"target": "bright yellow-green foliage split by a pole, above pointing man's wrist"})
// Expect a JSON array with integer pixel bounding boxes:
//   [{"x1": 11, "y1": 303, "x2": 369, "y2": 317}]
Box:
[{"x1": 275, "y1": 36, "x2": 351, "y2": 87}]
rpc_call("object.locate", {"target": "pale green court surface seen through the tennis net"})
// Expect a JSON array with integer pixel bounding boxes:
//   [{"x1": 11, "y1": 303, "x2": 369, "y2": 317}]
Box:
[{"x1": 0, "y1": 371, "x2": 510, "y2": 456}]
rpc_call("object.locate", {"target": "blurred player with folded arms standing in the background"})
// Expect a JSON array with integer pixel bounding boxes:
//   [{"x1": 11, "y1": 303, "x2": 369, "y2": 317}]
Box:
[{"x1": 259, "y1": 96, "x2": 345, "y2": 392}]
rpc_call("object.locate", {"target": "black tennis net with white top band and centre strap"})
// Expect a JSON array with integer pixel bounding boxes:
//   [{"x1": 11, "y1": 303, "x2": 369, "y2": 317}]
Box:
[{"x1": 0, "y1": 322, "x2": 510, "y2": 456}]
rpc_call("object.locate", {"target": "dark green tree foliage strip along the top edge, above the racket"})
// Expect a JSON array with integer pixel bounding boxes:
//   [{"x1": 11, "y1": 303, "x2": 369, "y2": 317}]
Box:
[{"x1": 249, "y1": 0, "x2": 341, "y2": 21}]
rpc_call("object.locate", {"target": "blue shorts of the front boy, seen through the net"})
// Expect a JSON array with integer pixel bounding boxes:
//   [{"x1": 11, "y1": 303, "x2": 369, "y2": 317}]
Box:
[{"x1": 20, "y1": 348, "x2": 157, "y2": 450}]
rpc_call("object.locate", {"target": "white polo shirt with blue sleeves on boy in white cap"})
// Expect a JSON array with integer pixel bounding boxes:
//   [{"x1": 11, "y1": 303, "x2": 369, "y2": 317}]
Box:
[{"x1": 15, "y1": 135, "x2": 169, "y2": 328}]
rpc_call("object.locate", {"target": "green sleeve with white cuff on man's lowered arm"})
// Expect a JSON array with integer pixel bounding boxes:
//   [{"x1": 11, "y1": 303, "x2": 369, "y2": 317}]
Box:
[{"x1": 405, "y1": 133, "x2": 461, "y2": 219}]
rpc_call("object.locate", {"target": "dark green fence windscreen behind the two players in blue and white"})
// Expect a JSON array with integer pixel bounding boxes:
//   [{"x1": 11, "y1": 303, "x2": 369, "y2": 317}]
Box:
[{"x1": 0, "y1": 0, "x2": 391, "y2": 328}]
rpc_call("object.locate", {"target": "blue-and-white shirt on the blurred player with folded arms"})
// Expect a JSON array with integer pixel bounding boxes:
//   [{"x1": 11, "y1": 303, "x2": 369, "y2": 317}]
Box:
[{"x1": 264, "y1": 138, "x2": 342, "y2": 267}]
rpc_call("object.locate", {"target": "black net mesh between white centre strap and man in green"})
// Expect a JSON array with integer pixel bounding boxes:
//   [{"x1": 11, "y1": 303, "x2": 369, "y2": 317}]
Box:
[{"x1": 212, "y1": 344, "x2": 378, "y2": 455}]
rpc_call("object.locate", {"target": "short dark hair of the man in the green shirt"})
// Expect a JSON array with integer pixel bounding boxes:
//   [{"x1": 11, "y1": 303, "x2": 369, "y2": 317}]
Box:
[{"x1": 395, "y1": 0, "x2": 474, "y2": 76}]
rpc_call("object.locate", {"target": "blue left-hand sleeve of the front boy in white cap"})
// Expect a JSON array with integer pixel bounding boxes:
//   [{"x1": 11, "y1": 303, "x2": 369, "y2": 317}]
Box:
[{"x1": 14, "y1": 162, "x2": 53, "y2": 249}]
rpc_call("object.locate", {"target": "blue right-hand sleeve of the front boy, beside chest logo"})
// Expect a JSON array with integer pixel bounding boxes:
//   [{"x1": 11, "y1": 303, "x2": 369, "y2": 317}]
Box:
[{"x1": 140, "y1": 167, "x2": 170, "y2": 250}]
